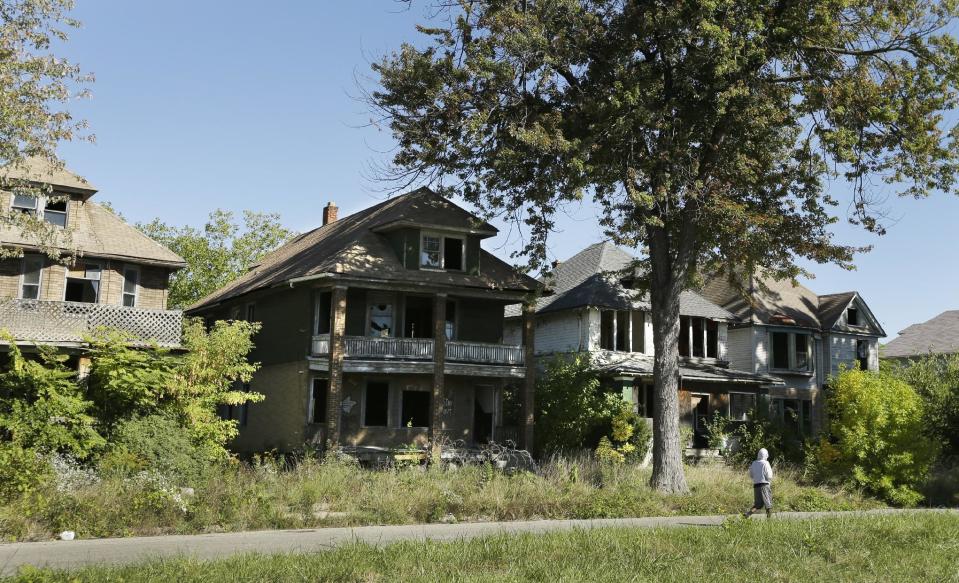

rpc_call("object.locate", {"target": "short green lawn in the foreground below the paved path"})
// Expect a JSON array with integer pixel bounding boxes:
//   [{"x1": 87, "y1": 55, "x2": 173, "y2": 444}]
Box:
[{"x1": 9, "y1": 514, "x2": 959, "y2": 583}]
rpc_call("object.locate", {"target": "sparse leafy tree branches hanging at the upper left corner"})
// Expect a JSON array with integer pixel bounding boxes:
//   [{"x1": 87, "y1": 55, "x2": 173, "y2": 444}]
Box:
[{"x1": 0, "y1": 0, "x2": 92, "y2": 258}]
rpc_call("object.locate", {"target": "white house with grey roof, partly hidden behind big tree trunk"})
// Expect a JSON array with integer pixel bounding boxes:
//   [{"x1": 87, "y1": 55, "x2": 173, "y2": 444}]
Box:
[{"x1": 506, "y1": 242, "x2": 780, "y2": 447}]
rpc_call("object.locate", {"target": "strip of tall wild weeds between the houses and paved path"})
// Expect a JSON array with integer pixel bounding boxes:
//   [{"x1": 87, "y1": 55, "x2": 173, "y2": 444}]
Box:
[{"x1": 0, "y1": 457, "x2": 881, "y2": 540}]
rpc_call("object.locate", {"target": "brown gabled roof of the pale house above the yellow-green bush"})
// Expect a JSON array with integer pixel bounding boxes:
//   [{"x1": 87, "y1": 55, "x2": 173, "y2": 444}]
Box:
[{"x1": 701, "y1": 275, "x2": 886, "y2": 336}]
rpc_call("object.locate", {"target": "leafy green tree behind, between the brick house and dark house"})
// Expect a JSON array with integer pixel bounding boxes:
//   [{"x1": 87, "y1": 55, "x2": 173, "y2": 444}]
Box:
[{"x1": 136, "y1": 209, "x2": 296, "y2": 308}]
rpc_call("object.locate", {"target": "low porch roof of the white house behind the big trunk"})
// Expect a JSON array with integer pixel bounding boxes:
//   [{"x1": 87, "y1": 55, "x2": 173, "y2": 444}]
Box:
[{"x1": 590, "y1": 350, "x2": 784, "y2": 385}]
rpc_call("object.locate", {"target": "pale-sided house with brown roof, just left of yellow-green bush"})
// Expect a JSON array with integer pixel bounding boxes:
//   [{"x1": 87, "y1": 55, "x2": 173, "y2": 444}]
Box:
[{"x1": 701, "y1": 276, "x2": 886, "y2": 435}]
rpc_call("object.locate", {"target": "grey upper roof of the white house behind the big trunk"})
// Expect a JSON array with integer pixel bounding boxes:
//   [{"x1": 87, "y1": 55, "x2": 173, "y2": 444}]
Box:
[{"x1": 506, "y1": 241, "x2": 733, "y2": 320}]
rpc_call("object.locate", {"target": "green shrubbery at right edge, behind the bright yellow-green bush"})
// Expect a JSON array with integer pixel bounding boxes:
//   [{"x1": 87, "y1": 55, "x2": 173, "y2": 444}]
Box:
[{"x1": 885, "y1": 354, "x2": 959, "y2": 457}]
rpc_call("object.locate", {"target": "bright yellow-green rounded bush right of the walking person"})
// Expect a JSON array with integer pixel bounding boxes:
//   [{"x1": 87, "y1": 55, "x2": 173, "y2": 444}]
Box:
[{"x1": 813, "y1": 370, "x2": 938, "y2": 505}]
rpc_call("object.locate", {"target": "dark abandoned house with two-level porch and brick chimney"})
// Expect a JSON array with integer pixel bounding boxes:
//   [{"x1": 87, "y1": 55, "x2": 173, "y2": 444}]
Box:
[{"x1": 188, "y1": 188, "x2": 538, "y2": 457}]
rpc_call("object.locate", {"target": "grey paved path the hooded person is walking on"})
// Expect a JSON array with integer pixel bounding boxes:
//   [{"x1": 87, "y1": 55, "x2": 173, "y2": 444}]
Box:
[{"x1": 0, "y1": 509, "x2": 959, "y2": 576}]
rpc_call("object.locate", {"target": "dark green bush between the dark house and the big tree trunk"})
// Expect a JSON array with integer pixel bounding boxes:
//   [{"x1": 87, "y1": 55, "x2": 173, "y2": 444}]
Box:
[{"x1": 535, "y1": 354, "x2": 623, "y2": 453}]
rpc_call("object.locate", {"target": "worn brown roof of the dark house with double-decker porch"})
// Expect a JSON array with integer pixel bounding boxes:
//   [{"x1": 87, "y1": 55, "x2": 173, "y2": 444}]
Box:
[{"x1": 184, "y1": 188, "x2": 539, "y2": 310}]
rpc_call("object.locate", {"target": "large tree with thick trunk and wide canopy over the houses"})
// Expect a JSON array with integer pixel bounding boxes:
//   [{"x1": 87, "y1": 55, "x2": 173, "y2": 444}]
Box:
[{"x1": 368, "y1": 0, "x2": 959, "y2": 492}]
